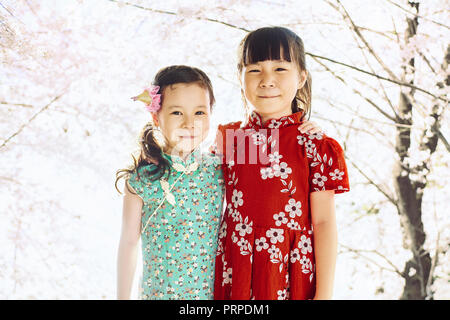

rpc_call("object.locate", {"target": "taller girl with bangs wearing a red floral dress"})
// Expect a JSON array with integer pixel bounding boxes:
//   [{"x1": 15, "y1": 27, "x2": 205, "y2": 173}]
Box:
[{"x1": 214, "y1": 27, "x2": 349, "y2": 299}]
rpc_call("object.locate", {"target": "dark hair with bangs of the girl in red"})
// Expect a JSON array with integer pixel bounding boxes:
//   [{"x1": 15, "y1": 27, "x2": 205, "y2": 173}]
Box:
[{"x1": 237, "y1": 27, "x2": 312, "y2": 118}]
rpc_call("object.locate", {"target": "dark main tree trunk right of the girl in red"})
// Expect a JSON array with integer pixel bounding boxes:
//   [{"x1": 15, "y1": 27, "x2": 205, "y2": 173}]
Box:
[{"x1": 393, "y1": 2, "x2": 431, "y2": 300}]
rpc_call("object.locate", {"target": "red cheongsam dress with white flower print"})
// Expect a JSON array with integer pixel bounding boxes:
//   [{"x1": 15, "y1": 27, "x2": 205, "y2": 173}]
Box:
[{"x1": 214, "y1": 112, "x2": 349, "y2": 300}]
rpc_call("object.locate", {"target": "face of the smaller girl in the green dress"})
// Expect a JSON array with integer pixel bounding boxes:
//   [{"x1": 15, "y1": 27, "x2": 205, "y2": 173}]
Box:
[{"x1": 152, "y1": 83, "x2": 210, "y2": 156}]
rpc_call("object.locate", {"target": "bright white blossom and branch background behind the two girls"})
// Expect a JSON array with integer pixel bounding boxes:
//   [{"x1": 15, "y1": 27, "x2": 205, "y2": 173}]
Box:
[{"x1": 0, "y1": 0, "x2": 450, "y2": 299}]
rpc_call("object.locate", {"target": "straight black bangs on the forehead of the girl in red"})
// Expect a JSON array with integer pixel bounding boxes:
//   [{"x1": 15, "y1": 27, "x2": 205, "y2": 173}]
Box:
[{"x1": 242, "y1": 28, "x2": 295, "y2": 66}]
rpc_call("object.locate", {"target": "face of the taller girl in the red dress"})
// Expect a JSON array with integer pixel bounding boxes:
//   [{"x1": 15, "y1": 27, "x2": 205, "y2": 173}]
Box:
[{"x1": 241, "y1": 52, "x2": 306, "y2": 121}]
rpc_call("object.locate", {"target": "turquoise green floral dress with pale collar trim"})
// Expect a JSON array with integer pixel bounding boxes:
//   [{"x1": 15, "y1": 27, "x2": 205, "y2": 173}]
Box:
[{"x1": 128, "y1": 151, "x2": 224, "y2": 300}]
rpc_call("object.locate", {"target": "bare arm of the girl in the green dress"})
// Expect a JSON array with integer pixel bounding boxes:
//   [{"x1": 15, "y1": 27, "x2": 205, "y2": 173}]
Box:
[{"x1": 117, "y1": 181, "x2": 143, "y2": 300}]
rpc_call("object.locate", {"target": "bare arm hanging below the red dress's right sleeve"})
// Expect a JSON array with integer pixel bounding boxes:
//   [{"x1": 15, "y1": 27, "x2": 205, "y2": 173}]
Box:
[{"x1": 310, "y1": 190, "x2": 337, "y2": 300}]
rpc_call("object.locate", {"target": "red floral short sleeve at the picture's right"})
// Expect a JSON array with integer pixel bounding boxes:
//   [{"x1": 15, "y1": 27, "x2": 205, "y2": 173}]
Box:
[{"x1": 305, "y1": 135, "x2": 350, "y2": 193}]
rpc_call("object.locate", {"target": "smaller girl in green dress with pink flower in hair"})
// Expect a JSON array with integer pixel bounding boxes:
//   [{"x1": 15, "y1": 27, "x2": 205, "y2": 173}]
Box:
[{"x1": 116, "y1": 66, "x2": 224, "y2": 300}]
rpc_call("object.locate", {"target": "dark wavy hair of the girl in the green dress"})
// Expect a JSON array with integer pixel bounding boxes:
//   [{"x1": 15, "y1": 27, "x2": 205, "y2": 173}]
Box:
[{"x1": 115, "y1": 65, "x2": 215, "y2": 193}]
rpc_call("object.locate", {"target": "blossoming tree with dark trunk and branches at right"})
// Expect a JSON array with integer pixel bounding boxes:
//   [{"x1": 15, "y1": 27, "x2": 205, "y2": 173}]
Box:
[{"x1": 322, "y1": 0, "x2": 450, "y2": 299}]
